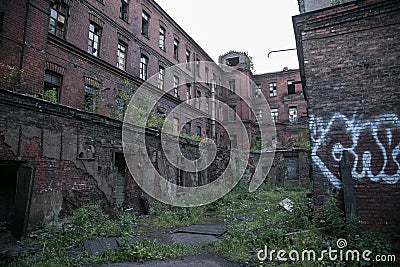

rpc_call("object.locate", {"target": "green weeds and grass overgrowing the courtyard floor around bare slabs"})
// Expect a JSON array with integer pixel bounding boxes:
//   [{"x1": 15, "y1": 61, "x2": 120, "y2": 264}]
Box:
[{"x1": 0, "y1": 185, "x2": 399, "y2": 266}]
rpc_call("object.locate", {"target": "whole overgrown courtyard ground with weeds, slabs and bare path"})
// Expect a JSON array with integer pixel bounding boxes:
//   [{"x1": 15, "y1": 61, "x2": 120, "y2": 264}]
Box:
[{"x1": 0, "y1": 183, "x2": 399, "y2": 267}]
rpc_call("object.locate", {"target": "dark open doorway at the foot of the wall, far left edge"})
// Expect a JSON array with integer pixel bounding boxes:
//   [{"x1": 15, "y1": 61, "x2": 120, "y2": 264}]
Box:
[{"x1": 0, "y1": 161, "x2": 33, "y2": 237}]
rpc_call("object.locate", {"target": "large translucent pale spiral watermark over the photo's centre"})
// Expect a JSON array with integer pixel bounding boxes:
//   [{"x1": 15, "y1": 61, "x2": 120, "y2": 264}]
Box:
[{"x1": 122, "y1": 62, "x2": 276, "y2": 207}]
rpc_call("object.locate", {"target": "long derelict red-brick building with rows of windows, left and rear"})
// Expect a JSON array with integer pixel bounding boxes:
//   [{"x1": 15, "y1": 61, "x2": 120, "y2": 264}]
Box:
[{"x1": 0, "y1": 0, "x2": 307, "y2": 237}]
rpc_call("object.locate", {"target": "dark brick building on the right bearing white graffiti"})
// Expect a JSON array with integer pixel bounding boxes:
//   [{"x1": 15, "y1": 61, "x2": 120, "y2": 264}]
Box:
[{"x1": 293, "y1": 0, "x2": 400, "y2": 234}]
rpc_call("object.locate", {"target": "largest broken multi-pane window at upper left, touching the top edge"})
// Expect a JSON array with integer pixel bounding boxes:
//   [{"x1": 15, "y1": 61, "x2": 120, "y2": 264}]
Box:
[{"x1": 49, "y1": 1, "x2": 68, "y2": 38}]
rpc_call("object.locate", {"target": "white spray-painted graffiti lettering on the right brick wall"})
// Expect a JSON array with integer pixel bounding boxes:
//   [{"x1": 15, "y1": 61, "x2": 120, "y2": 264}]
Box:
[{"x1": 310, "y1": 113, "x2": 400, "y2": 188}]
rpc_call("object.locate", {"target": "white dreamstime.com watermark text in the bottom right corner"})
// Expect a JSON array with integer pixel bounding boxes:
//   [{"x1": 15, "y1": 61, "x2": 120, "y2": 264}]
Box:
[{"x1": 257, "y1": 238, "x2": 396, "y2": 262}]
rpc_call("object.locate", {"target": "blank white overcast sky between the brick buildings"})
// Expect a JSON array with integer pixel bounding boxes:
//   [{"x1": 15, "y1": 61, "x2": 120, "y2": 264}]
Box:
[{"x1": 156, "y1": 0, "x2": 299, "y2": 74}]
